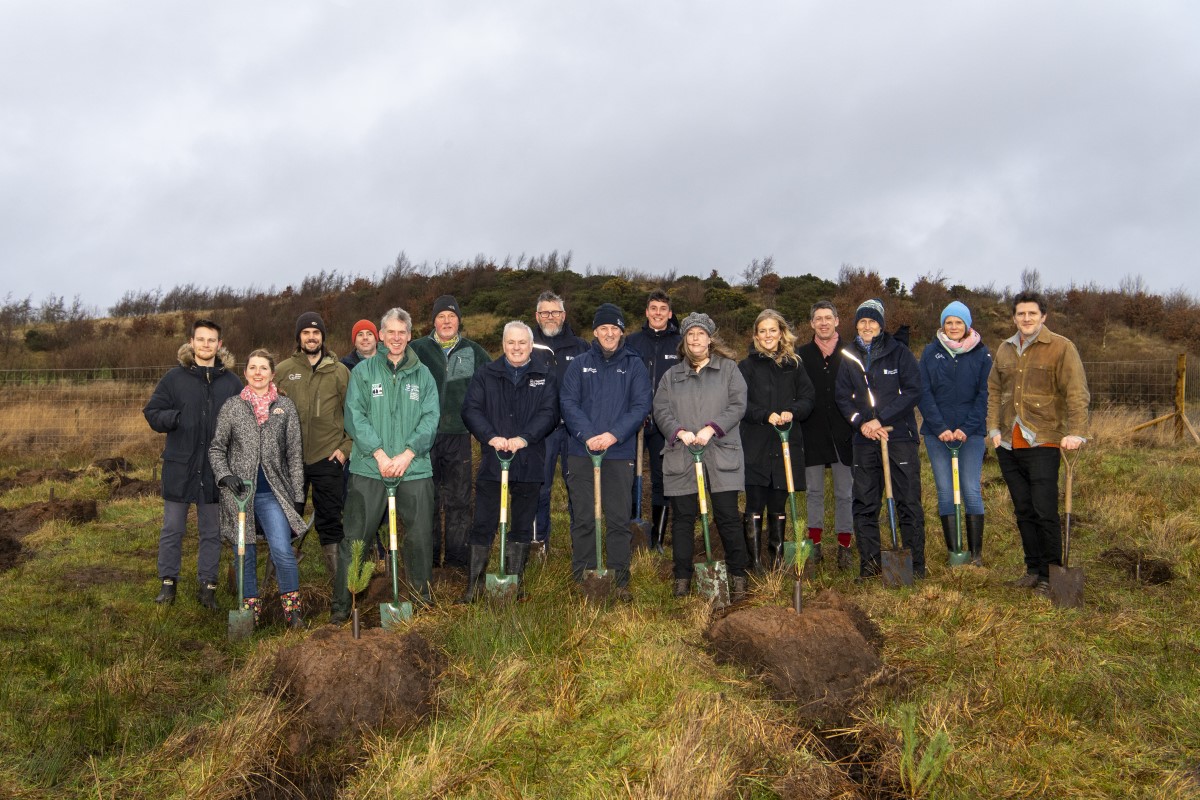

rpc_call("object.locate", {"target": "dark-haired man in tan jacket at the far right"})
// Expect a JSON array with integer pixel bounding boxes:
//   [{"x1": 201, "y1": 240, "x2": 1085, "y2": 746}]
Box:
[{"x1": 986, "y1": 291, "x2": 1091, "y2": 595}]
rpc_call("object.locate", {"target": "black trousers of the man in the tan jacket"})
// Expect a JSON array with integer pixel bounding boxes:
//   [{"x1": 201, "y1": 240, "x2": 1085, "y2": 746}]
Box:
[{"x1": 996, "y1": 447, "x2": 1062, "y2": 581}]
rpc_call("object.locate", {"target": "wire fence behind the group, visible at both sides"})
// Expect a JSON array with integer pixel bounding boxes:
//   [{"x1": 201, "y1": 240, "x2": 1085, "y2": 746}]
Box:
[{"x1": 0, "y1": 357, "x2": 1200, "y2": 461}]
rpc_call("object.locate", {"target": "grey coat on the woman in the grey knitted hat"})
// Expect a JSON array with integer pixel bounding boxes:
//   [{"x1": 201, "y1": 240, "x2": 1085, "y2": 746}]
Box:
[{"x1": 654, "y1": 354, "x2": 746, "y2": 498}]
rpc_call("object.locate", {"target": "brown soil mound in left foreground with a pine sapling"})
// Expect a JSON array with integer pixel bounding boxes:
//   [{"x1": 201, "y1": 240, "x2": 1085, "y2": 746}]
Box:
[{"x1": 271, "y1": 626, "x2": 445, "y2": 752}]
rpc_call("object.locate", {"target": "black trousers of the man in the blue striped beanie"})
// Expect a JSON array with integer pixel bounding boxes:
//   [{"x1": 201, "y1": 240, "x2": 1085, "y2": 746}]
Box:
[{"x1": 853, "y1": 440, "x2": 925, "y2": 576}]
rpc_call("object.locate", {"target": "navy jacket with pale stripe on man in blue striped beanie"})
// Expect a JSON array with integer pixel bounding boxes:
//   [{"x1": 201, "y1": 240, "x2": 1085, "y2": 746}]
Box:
[{"x1": 836, "y1": 333, "x2": 920, "y2": 443}]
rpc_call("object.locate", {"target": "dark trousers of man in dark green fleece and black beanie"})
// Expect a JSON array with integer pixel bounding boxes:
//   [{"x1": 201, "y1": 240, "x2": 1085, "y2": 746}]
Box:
[{"x1": 430, "y1": 433, "x2": 470, "y2": 571}]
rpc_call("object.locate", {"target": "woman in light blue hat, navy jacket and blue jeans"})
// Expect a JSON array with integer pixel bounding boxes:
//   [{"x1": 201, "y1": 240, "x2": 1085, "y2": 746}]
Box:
[{"x1": 918, "y1": 300, "x2": 991, "y2": 566}]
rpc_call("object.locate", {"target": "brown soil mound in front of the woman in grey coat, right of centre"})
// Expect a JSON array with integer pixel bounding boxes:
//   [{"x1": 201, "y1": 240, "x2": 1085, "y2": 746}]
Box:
[{"x1": 704, "y1": 589, "x2": 883, "y2": 718}]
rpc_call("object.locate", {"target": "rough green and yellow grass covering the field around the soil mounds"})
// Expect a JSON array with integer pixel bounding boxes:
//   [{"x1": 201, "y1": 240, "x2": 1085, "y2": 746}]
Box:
[{"x1": 0, "y1": 447, "x2": 1200, "y2": 799}]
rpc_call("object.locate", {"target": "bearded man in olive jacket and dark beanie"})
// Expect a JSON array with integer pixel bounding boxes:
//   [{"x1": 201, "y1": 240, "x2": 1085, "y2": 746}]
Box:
[{"x1": 276, "y1": 311, "x2": 350, "y2": 581}]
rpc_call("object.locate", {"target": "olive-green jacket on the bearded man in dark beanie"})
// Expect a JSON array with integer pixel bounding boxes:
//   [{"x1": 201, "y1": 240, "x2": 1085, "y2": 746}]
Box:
[{"x1": 275, "y1": 351, "x2": 350, "y2": 464}]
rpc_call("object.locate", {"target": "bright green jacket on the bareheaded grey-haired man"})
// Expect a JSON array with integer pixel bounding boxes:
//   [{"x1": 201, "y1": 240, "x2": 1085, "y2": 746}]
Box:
[{"x1": 346, "y1": 347, "x2": 438, "y2": 481}]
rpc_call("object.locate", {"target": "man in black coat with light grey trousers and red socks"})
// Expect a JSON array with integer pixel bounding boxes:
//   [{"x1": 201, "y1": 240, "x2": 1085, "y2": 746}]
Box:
[{"x1": 797, "y1": 300, "x2": 854, "y2": 570}]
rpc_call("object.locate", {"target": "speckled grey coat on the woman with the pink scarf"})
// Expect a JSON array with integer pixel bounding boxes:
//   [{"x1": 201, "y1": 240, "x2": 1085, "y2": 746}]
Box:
[{"x1": 209, "y1": 395, "x2": 305, "y2": 542}]
